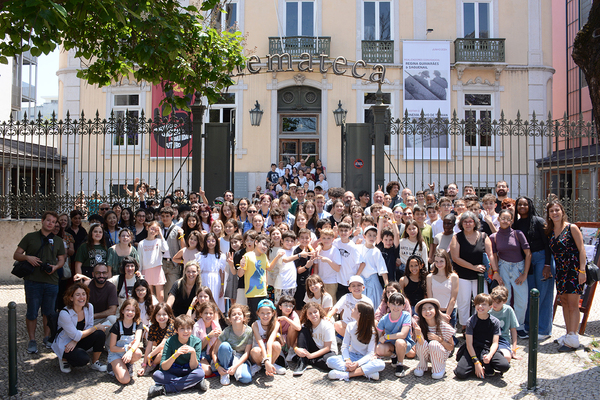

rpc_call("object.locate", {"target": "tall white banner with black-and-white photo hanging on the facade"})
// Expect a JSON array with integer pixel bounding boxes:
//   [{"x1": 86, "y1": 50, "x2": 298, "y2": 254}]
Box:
[{"x1": 402, "y1": 41, "x2": 450, "y2": 160}]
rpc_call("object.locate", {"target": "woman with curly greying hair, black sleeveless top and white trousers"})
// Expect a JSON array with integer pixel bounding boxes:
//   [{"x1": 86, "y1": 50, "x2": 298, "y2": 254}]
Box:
[{"x1": 452, "y1": 210, "x2": 494, "y2": 326}]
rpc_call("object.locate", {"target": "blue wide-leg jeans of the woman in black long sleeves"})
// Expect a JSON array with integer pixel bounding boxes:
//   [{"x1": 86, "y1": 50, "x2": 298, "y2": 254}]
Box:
[{"x1": 524, "y1": 250, "x2": 554, "y2": 335}]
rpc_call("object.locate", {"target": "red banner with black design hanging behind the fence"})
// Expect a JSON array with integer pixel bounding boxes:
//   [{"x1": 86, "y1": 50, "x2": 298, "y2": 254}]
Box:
[{"x1": 150, "y1": 85, "x2": 192, "y2": 158}]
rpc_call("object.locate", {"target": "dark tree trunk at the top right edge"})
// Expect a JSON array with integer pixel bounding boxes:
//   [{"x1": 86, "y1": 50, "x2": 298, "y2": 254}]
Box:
[{"x1": 573, "y1": 0, "x2": 600, "y2": 135}]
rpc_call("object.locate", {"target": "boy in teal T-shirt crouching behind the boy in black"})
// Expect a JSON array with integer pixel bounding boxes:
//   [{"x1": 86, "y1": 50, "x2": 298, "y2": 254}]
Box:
[{"x1": 490, "y1": 286, "x2": 521, "y2": 362}]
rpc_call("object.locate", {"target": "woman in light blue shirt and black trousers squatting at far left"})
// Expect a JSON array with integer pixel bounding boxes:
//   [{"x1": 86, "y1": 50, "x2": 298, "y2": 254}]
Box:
[{"x1": 52, "y1": 282, "x2": 107, "y2": 373}]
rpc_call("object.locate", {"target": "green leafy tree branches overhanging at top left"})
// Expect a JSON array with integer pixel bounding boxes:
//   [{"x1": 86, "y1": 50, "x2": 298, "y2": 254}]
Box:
[{"x1": 0, "y1": 0, "x2": 244, "y2": 114}]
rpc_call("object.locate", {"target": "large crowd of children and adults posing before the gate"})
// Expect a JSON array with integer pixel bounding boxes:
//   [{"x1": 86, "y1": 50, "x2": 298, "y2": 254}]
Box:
[{"x1": 14, "y1": 173, "x2": 586, "y2": 397}]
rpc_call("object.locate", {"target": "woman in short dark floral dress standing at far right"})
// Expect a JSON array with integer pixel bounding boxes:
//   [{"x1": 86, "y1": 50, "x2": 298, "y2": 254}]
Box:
[{"x1": 545, "y1": 201, "x2": 586, "y2": 352}]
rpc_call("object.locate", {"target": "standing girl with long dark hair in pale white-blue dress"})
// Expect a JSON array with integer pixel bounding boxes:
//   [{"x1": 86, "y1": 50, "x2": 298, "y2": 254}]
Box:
[{"x1": 196, "y1": 232, "x2": 226, "y2": 311}]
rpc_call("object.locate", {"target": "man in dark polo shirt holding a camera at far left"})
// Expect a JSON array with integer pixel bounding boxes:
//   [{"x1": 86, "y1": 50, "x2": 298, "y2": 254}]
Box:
[{"x1": 13, "y1": 211, "x2": 65, "y2": 354}]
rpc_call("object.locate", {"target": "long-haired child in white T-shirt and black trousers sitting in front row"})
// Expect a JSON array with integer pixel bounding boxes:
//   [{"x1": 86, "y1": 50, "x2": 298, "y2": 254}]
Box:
[{"x1": 294, "y1": 304, "x2": 338, "y2": 376}]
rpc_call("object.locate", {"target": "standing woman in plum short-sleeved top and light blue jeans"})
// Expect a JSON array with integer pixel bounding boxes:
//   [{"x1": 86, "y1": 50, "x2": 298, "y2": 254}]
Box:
[{"x1": 490, "y1": 209, "x2": 531, "y2": 337}]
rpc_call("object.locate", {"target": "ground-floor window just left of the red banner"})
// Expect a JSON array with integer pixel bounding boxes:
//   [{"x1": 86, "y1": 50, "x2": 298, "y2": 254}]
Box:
[{"x1": 111, "y1": 94, "x2": 143, "y2": 146}]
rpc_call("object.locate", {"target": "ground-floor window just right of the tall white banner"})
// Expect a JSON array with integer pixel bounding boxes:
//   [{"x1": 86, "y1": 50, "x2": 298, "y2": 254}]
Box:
[{"x1": 464, "y1": 94, "x2": 492, "y2": 147}]
